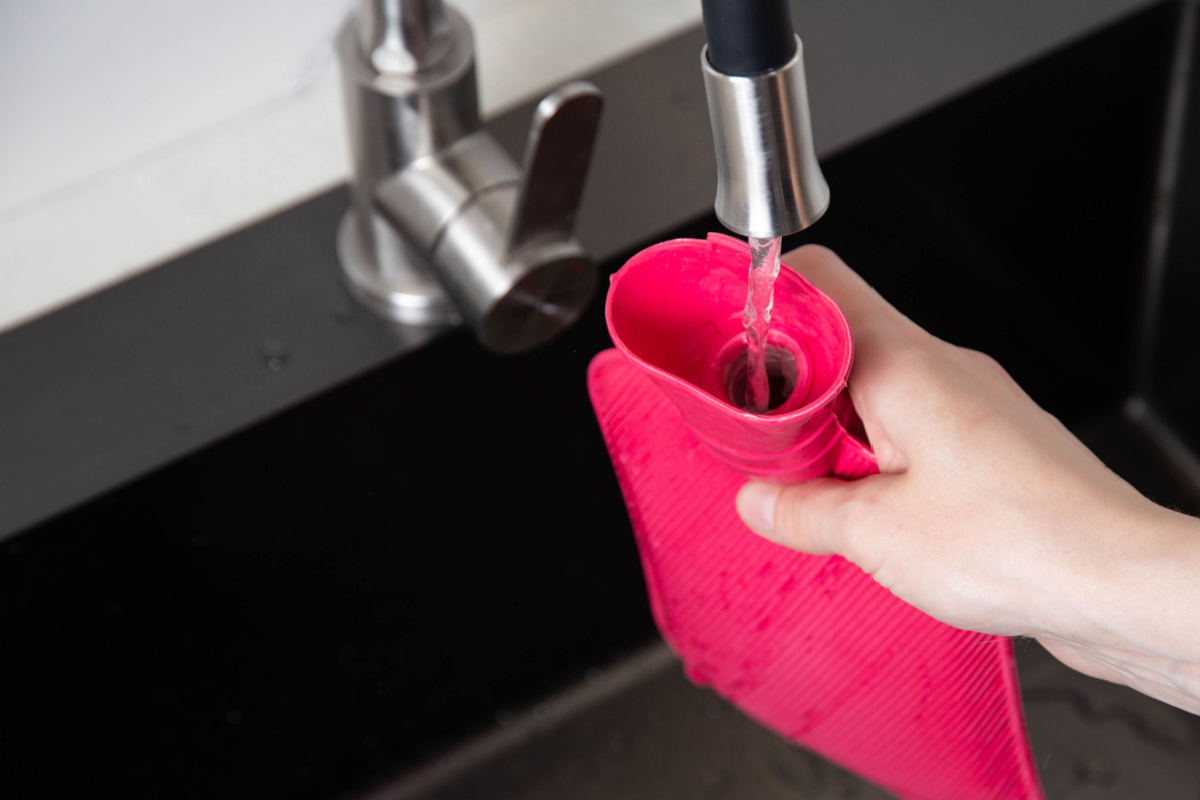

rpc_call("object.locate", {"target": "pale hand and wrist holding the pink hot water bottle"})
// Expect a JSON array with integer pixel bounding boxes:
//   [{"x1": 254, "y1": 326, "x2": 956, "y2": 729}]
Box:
[{"x1": 738, "y1": 246, "x2": 1200, "y2": 714}]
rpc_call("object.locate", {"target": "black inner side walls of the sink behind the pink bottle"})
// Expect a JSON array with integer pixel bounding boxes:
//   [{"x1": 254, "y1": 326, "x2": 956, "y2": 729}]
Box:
[{"x1": 0, "y1": 5, "x2": 1200, "y2": 798}]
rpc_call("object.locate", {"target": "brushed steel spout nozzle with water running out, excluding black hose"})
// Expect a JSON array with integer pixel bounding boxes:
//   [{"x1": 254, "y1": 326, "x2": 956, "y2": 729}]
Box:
[{"x1": 701, "y1": 36, "x2": 829, "y2": 237}]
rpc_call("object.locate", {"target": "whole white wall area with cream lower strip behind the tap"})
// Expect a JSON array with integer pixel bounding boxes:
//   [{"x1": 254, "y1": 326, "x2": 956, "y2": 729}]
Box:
[{"x1": 0, "y1": 0, "x2": 700, "y2": 333}]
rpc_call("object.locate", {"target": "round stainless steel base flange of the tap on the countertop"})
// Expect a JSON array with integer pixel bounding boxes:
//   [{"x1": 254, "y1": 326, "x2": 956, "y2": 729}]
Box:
[{"x1": 337, "y1": 207, "x2": 462, "y2": 326}]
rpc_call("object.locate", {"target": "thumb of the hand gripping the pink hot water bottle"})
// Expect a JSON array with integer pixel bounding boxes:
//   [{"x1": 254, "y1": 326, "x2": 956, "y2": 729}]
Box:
[{"x1": 737, "y1": 475, "x2": 902, "y2": 563}]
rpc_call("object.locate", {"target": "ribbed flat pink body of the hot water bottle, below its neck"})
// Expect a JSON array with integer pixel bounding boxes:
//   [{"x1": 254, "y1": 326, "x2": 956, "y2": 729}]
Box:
[{"x1": 588, "y1": 350, "x2": 1043, "y2": 800}]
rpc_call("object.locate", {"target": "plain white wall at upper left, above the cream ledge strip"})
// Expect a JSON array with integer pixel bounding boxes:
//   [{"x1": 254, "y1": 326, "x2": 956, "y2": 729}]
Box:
[{"x1": 0, "y1": 0, "x2": 508, "y2": 211}]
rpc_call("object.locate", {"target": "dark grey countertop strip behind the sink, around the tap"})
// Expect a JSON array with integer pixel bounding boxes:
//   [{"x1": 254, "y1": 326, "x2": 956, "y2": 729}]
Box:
[{"x1": 0, "y1": 0, "x2": 1171, "y2": 539}]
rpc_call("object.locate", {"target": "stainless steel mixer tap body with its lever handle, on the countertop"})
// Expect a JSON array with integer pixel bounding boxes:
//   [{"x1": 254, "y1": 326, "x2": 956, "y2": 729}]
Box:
[{"x1": 337, "y1": 0, "x2": 602, "y2": 354}]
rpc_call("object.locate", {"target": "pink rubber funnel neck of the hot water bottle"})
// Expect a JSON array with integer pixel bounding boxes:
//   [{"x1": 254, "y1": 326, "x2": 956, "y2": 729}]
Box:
[{"x1": 605, "y1": 234, "x2": 876, "y2": 483}]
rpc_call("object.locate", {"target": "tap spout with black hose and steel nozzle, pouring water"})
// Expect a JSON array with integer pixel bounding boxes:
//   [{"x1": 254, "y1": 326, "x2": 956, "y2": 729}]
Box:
[{"x1": 701, "y1": 0, "x2": 829, "y2": 239}]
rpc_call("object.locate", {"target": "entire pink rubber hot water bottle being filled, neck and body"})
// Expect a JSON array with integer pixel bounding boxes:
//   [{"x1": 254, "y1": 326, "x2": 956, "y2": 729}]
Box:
[{"x1": 588, "y1": 234, "x2": 1043, "y2": 800}]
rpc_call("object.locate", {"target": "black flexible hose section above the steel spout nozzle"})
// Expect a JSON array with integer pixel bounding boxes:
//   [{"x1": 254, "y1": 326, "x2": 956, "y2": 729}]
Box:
[{"x1": 702, "y1": 0, "x2": 796, "y2": 76}]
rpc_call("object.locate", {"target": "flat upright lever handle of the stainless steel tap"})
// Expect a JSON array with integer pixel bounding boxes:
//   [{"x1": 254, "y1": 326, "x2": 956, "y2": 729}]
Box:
[{"x1": 508, "y1": 80, "x2": 604, "y2": 253}]
